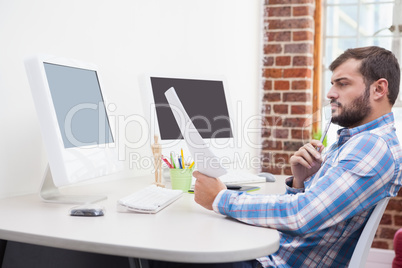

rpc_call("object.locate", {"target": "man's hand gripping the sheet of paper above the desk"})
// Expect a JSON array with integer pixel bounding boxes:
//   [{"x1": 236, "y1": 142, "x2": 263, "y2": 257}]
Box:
[{"x1": 193, "y1": 171, "x2": 227, "y2": 210}]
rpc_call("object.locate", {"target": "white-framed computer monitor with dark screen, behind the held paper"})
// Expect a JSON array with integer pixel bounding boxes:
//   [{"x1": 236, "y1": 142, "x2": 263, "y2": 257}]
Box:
[{"x1": 144, "y1": 76, "x2": 235, "y2": 162}]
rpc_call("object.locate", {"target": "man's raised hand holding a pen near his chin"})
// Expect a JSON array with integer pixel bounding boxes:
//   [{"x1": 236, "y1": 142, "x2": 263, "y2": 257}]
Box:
[{"x1": 290, "y1": 140, "x2": 324, "y2": 188}]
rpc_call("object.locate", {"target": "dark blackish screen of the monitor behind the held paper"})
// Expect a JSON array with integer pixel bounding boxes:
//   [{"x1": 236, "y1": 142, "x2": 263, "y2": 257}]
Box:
[{"x1": 151, "y1": 77, "x2": 233, "y2": 140}]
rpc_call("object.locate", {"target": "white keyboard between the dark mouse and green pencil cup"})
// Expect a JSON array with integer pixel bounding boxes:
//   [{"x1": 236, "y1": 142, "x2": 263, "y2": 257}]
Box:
[{"x1": 117, "y1": 185, "x2": 183, "y2": 213}]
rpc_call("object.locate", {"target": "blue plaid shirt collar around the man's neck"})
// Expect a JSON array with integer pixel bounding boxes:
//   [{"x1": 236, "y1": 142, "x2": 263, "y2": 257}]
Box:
[{"x1": 338, "y1": 112, "x2": 394, "y2": 144}]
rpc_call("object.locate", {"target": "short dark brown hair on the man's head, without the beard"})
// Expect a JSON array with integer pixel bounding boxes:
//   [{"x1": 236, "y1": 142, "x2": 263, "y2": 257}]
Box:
[{"x1": 329, "y1": 46, "x2": 401, "y2": 105}]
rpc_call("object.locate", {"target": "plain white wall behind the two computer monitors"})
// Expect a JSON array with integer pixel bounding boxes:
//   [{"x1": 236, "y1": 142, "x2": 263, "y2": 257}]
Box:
[{"x1": 0, "y1": 0, "x2": 262, "y2": 197}]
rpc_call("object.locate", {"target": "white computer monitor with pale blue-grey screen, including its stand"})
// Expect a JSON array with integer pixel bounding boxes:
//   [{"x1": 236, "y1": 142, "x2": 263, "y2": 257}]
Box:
[{"x1": 25, "y1": 56, "x2": 123, "y2": 203}]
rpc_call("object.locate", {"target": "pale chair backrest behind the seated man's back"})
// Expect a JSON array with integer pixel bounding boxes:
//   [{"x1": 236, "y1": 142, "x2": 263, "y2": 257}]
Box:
[{"x1": 349, "y1": 197, "x2": 389, "y2": 268}]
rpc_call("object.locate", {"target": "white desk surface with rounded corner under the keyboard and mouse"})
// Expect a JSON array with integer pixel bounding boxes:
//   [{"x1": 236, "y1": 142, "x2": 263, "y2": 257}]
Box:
[{"x1": 0, "y1": 176, "x2": 284, "y2": 263}]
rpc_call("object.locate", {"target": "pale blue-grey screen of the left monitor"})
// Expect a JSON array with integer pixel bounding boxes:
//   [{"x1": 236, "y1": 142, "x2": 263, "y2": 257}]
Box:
[{"x1": 44, "y1": 63, "x2": 113, "y2": 148}]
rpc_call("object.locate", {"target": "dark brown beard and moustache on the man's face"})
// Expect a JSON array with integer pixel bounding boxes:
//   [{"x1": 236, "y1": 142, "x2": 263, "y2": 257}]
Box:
[{"x1": 331, "y1": 88, "x2": 371, "y2": 127}]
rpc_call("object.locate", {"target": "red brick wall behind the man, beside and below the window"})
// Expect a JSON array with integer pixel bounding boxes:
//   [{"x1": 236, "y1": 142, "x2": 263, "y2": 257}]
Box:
[{"x1": 261, "y1": 0, "x2": 402, "y2": 249}]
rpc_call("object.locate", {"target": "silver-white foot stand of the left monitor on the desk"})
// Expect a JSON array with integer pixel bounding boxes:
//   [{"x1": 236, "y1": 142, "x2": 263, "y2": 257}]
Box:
[{"x1": 40, "y1": 165, "x2": 107, "y2": 204}]
